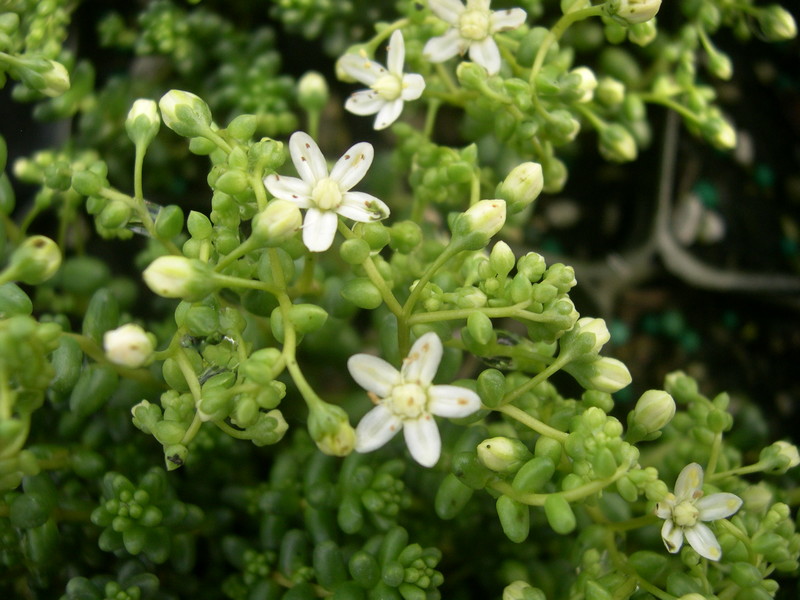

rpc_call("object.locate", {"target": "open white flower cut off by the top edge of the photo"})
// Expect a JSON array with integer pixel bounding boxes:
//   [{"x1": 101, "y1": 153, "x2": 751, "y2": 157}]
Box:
[{"x1": 422, "y1": 0, "x2": 527, "y2": 75}]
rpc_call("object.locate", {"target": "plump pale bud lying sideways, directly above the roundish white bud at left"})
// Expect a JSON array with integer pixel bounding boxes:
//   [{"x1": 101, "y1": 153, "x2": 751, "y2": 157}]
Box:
[{"x1": 142, "y1": 256, "x2": 217, "y2": 302}]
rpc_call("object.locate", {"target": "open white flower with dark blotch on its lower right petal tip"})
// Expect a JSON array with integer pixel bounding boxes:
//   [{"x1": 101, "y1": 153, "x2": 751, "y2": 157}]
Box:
[{"x1": 264, "y1": 131, "x2": 389, "y2": 252}]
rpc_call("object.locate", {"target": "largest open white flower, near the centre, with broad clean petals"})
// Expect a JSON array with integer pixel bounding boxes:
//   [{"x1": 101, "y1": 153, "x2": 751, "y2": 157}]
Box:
[{"x1": 347, "y1": 332, "x2": 481, "y2": 467}]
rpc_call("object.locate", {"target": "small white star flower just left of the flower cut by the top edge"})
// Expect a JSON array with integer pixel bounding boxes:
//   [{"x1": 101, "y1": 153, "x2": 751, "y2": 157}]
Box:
[{"x1": 338, "y1": 30, "x2": 425, "y2": 129}]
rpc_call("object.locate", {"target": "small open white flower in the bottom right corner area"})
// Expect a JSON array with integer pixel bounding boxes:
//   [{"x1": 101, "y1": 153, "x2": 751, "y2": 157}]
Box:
[{"x1": 656, "y1": 463, "x2": 742, "y2": 560}]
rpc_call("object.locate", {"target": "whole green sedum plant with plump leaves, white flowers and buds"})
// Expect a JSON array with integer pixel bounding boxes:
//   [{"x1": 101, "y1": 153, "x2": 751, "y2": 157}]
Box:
[{"x1": 0, "y1": 0, "x2": 800, "y2": 600}]
